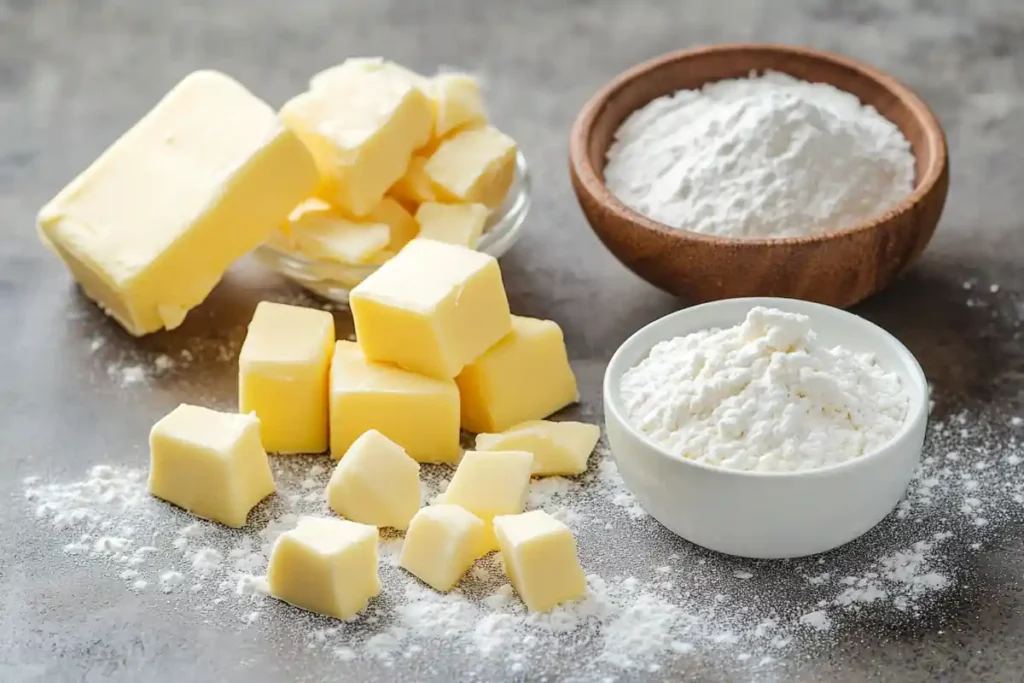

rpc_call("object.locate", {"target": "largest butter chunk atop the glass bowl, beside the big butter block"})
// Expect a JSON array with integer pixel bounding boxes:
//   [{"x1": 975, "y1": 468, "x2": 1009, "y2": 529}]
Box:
[{"x1": 281, "y1": 69, "x2": 433, "y2": 216}]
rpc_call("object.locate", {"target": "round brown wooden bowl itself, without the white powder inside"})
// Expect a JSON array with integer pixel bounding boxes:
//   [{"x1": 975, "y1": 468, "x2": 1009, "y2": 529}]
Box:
[{"x1": 569, "y1": 45, "x2": 949, "y2": 307}]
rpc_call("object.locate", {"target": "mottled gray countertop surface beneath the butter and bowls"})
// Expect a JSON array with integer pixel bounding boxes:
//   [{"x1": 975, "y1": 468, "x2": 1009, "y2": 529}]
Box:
[{"x1": 0, "y1": 0, "x2": 1024, "y2": 683}]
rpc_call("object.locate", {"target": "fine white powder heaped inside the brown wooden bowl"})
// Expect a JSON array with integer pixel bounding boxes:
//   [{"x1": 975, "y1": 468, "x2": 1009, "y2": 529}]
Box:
[{"x1": 604, "y1": 72, "x2": 914, "y2": 238}]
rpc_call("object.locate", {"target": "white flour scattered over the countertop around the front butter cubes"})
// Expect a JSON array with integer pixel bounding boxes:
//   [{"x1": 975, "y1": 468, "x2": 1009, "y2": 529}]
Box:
[{"x1": 24, "y1": 393, "x2": 1024, "y2": 681}]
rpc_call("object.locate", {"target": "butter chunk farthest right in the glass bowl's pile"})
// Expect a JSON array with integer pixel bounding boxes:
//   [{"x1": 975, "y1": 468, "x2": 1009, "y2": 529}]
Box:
[{"x1": 424, "y1": 127, "x2": 516, "y2": 207}]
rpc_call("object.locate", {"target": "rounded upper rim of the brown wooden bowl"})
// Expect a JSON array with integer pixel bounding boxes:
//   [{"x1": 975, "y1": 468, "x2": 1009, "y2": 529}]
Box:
[{"x1": 569, "y1": 43, "x2": 948, "y2": 248}]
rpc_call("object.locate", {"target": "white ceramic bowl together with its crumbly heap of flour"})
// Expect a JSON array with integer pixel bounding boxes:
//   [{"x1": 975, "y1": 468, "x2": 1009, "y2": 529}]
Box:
[{"x1": 604, "y1": 298, "x2": 928, "y2": 558}]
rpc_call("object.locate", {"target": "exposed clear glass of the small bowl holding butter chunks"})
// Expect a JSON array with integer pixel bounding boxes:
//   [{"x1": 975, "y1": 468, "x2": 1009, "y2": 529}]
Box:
[{"x1": 253, "y1": 152, "x2": 530, "y2": 304}]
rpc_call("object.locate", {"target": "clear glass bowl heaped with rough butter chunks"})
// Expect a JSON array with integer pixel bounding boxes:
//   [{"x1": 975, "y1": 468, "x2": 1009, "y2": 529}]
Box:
[{"x1": 254, "y1": 57, "x2": 530, "y2": 303}]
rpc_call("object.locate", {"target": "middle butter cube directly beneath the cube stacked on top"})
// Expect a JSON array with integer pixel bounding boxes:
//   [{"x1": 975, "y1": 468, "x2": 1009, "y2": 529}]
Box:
[{"x1": 331, "y1": 338, "x2": 462, "y2": 463}]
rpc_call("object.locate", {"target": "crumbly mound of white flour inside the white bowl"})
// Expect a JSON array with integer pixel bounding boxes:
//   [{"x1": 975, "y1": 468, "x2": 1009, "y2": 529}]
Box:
[{"x1": 620, "y1": 307, "x2": 909, "y2": 472}]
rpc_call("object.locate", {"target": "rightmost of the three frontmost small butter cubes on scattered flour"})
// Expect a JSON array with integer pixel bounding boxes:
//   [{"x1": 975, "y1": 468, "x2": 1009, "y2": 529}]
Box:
[{"x1": 494, "y1": 510, "x2": 587, "y2": 612}]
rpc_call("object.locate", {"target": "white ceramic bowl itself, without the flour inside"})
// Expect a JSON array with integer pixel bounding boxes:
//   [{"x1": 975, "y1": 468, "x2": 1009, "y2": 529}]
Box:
[{"x1": 604, "y1": 298, "x2": 928, "y2": 558}]
